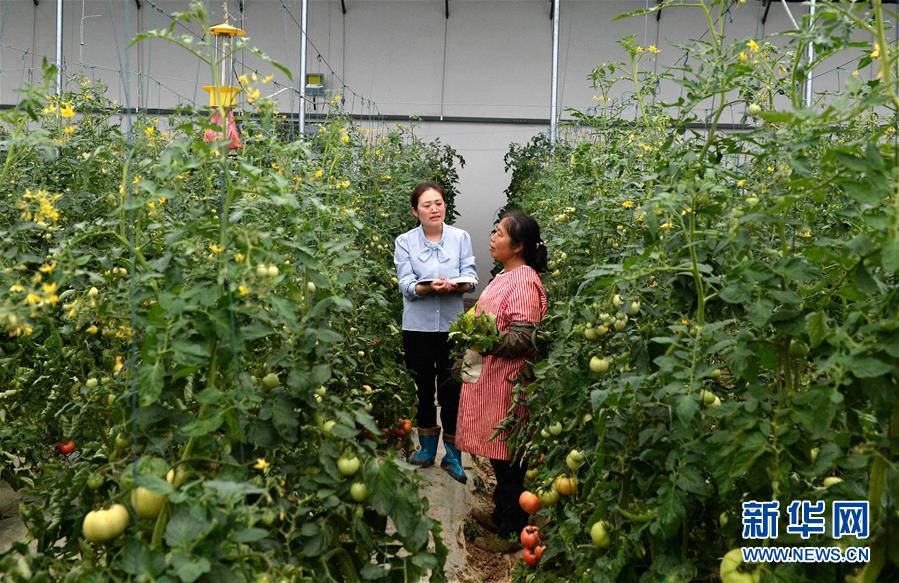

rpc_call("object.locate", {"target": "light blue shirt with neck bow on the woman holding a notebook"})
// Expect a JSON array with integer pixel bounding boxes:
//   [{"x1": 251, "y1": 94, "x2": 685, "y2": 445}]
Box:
[{"x1": 393, "y1": 224, "x2": 478, "y2": 332}]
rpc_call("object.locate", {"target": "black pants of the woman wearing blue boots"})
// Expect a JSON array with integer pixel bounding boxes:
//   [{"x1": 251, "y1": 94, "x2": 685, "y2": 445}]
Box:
[{"x1": 403, "y1": 330, "x2": 462, "y2": 435}]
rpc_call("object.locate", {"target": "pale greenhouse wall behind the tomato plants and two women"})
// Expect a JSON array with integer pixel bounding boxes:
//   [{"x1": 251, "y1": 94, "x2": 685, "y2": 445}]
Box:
[{"x1": 0, "y1": 0, "x2": 893, "y2": 290}]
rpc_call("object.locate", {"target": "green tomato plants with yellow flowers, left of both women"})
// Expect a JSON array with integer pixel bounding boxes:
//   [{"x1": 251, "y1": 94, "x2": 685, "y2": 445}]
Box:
[{"x1": 0, "y1": 5, "x2": 459, "y2": 581}]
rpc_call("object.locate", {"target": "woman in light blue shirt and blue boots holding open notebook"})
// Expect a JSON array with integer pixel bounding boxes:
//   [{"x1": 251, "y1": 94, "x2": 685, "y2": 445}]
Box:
[{"x1": 393, "y1": 182, "x2": 477, "y2": 484}]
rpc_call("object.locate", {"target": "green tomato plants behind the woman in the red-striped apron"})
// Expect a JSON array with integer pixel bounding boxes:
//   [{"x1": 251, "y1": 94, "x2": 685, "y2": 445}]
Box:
[{"x1": 506, "y1": 3, "x2": 899, "y2": 581}]
